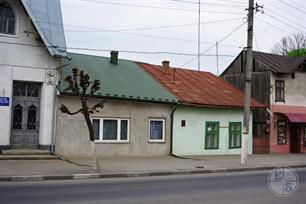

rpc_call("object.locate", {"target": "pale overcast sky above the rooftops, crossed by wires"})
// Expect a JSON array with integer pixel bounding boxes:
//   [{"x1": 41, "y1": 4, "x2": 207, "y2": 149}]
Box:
[{"x1": 61, "y1": 0, "x2": 306, "y2": 74}]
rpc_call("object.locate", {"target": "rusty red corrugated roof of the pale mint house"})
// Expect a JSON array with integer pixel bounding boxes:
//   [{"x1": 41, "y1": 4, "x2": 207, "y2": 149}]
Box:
[{"x1": 138, "y1": 63, "x2": 265, "y2": 108}]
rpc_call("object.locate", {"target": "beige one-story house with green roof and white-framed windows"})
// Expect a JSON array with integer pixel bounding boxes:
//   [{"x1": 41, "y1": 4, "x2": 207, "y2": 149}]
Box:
[{"x1": 56, "y1": 52, "x2": 177, "y2": 158}]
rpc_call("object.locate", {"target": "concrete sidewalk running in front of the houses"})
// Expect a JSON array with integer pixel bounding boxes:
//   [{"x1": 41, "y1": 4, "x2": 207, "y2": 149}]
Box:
[{"x1": 0, "y1": 154, "x2": 306, "y2": 181}]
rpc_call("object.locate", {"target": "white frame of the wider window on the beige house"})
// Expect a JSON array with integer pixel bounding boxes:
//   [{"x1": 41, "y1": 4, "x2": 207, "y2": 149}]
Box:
[{"x1": 91, "y1": 117, "x2": 130, "y2": 143}]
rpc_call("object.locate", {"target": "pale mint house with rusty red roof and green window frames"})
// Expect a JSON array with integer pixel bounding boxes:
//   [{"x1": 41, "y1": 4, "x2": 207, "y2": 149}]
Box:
[{"x1": 139, "y1": 61, "x2": 264, "y2": 156}]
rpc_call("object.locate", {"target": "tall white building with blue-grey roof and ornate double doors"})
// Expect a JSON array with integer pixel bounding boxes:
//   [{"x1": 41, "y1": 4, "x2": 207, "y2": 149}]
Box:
[{"x1": 0, "y1": 0, "x2": 66, "y2": 150}]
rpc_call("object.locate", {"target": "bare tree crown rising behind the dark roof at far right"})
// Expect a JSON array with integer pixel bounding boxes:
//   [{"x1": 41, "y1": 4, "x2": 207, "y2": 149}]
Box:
[{"x1": 272, "y1": 33, "x2": 306, "y2": 56}]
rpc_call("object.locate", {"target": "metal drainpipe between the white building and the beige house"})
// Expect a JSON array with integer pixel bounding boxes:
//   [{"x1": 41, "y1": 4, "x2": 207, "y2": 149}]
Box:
[{"x1": 50, "y1": 57, "x2": 72, "y2": 154}]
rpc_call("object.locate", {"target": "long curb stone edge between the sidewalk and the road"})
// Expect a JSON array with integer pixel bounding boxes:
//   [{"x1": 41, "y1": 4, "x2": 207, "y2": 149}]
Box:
[{"x1": 0, "y1": 164, "x2": 306, "y2": 182}]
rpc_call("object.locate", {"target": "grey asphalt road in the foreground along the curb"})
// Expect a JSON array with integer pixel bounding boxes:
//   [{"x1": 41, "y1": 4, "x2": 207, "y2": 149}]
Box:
[{"x1": 0, "y1": 169, "x2": 306, "y2": 204}]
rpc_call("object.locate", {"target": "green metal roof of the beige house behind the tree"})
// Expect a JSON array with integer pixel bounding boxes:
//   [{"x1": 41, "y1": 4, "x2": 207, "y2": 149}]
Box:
[{"x1": 59, "y1": 53, "x2": 177, "y2": 103}]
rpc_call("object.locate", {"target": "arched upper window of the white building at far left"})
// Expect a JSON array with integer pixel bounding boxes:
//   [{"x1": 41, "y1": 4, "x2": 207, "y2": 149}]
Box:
[{"x1": 0, "y1": 0, "x2": 16, "y2": 35}]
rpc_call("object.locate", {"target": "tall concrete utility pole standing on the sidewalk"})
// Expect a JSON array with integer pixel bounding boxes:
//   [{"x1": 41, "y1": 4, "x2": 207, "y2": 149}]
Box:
[{"x1": 241, "y1": 0, "x2": 255, "y2": 164}]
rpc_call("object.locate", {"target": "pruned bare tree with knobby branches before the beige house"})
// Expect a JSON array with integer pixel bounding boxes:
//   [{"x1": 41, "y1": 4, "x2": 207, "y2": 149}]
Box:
[{"x1": 60, "y1": 68, "x2": 104, "y2": 171}]
